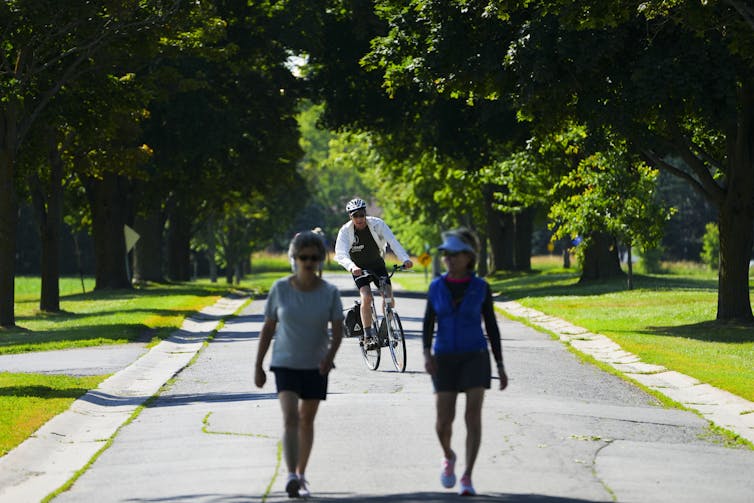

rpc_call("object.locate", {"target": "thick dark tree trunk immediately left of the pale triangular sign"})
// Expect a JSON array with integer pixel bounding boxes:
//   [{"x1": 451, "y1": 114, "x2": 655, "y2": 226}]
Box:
[{"x1": 85, "y1": 173, "x2": 131, "y2": 290}]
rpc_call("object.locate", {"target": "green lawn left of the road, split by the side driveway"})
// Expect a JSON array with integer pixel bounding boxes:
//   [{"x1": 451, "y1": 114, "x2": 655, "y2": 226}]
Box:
[{"x1": 0, "y1": 273, "x2": 258, "y2": 462}]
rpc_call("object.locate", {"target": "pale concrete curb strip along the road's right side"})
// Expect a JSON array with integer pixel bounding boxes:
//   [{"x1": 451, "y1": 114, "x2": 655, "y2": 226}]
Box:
[{"x1": 495, "y1": 301, "x2": 754, "y2": 443}]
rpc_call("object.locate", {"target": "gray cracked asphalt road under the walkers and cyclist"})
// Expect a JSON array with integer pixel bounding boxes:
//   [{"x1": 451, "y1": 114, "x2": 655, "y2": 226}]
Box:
[{"x1": 1, "y1": 276, "x2": 754, "y2": 503}]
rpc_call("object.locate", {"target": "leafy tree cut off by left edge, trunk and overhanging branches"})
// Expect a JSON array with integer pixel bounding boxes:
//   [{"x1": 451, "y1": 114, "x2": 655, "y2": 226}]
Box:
[{"x1": 0, "y1": 0, "x2": 175, "y2": 327}]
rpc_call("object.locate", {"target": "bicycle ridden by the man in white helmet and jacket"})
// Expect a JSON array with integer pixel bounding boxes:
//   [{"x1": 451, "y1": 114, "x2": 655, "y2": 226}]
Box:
[{"x1": 344, "y1": 265, "x2": 406, "y2": 372}]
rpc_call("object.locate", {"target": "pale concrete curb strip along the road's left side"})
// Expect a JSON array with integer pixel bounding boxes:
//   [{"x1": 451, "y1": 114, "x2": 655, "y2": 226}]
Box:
[{"x1": 0, "y1": 298, "x2": 247, "y2": 502}]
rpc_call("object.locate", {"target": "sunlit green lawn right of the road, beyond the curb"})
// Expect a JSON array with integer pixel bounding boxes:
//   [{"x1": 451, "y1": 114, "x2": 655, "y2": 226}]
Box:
[{"x1": 488, "y1": 262, "x2": 754, "y2": 401}]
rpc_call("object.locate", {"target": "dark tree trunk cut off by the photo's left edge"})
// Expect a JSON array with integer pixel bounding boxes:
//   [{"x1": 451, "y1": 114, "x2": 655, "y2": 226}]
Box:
[{"x1": 0, "y1": 107, "x2": 18, "y2": 327}]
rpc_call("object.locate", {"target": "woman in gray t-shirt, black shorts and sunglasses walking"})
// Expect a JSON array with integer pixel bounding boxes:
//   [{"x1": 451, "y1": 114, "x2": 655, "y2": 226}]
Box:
[{"x1": 254, "y1": 231, "x2": 343, "y2": 498}]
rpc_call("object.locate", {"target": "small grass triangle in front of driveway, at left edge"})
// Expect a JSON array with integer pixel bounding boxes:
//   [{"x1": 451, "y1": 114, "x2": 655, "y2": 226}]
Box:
[{"x1": 0, "y1": 372, "x2": 107, "y2": 456}]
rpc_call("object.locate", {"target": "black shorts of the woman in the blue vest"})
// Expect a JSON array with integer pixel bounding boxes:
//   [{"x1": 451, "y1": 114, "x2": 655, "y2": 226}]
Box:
[{"x1": 432, "y1": 350, "x2": 492, "y2": 392}]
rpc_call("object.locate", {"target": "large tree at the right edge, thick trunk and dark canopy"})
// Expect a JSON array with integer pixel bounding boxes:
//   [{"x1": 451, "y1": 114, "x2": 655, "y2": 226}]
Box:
[{"x1": 500, "y1": 2, "x2": 754, "y2": 322}]
